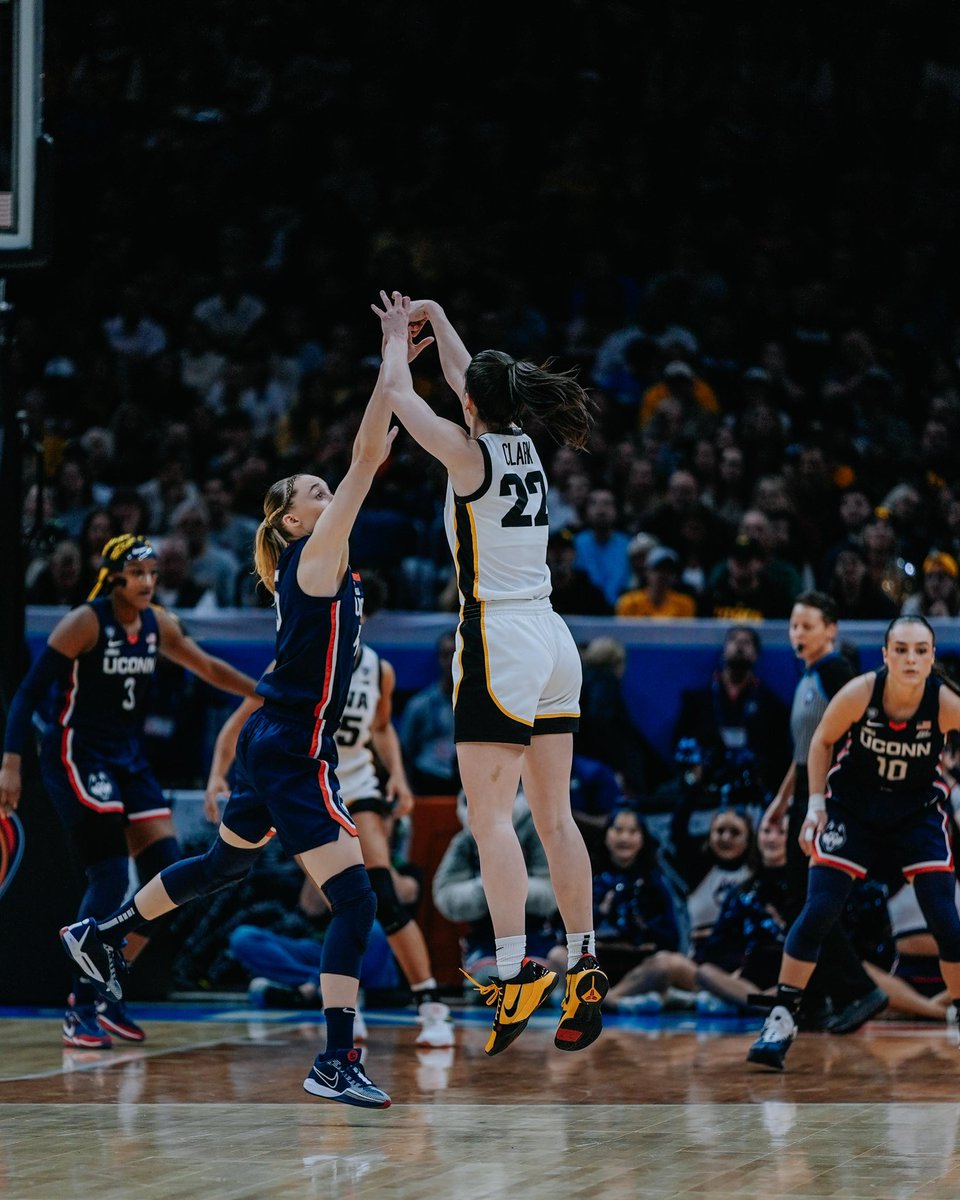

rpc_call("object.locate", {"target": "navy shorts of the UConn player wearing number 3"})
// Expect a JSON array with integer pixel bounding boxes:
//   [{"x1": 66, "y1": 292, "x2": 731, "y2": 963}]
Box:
[{"x1": 40, "y1": 726, "x2": 170, "y2": 828}]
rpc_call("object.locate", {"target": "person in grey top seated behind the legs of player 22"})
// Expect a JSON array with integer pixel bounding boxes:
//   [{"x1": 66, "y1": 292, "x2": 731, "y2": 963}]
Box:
[{"x1": 433, "y1": 792, "x2": 557, "y2": 1001}]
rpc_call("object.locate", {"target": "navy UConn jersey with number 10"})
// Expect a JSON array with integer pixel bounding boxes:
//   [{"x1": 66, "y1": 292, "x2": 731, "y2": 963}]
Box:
[{"x1": 827, "y1": 667, "x2": 948, "y2": 812}]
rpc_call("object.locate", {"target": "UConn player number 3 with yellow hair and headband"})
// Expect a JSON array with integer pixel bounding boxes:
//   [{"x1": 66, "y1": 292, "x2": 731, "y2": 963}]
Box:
[{"x1": 0, "y1": 534, "x2": 254, "y2": 1050}]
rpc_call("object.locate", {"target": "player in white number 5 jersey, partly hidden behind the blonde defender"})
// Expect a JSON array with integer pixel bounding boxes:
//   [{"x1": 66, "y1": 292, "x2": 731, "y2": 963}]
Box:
[{"x1": 204, "y1": 575, "x2": 454, "y2": 1049}]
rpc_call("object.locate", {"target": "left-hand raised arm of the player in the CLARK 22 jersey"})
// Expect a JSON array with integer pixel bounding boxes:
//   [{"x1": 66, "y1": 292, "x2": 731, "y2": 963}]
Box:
[{"x1": 371, "y1": 292, "x2": 484, "y2": 493}]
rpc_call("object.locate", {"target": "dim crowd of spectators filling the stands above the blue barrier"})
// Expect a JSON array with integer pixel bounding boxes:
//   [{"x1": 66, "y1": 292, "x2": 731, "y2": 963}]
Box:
[{"x1": 8, "y1": 9, "x2": 960, "y2": 619}]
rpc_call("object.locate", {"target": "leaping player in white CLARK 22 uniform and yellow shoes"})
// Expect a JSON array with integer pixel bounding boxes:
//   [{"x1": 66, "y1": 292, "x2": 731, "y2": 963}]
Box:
[{"x1": 374, "y1": 296, "x2": 607, "y2": 1055}]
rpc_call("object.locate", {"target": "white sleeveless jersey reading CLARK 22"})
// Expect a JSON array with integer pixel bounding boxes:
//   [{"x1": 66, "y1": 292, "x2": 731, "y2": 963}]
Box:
[{"x1": 444, "y1": 426, "x2": 551, "y2": 604}]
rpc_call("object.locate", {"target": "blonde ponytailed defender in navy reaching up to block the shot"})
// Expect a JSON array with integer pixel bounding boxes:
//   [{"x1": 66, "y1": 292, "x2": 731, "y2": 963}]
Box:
[{"x1": 61, "y1": 295, "x2": 419, "y2": 1109}]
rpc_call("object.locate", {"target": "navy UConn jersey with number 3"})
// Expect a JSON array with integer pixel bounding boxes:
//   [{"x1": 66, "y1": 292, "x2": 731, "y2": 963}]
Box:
[{"x1": 56, "y1": 596, "x2": 160, "y2": 742}]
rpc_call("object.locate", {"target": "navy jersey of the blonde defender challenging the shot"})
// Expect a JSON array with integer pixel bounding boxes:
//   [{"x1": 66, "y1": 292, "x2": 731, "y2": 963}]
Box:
[{"x1": 257, "y1": 538, "x2": 364, "y2": 752}]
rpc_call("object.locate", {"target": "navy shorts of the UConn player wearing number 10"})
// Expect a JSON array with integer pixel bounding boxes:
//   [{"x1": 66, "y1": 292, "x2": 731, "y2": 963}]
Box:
[{"x1": 812, "y1": 798, "x2": 953, "y2": 880}]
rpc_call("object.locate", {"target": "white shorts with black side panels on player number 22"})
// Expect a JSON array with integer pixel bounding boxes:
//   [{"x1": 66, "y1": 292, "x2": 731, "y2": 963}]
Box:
[{"x1": 454, "y1": 600, "x2": 582, "y2": 745}]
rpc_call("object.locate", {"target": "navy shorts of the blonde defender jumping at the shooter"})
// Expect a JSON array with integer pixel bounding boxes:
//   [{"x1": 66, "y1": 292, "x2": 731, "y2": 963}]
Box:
[{"x1": 223, "y1": 708, "x2": 356, "y2": 856}]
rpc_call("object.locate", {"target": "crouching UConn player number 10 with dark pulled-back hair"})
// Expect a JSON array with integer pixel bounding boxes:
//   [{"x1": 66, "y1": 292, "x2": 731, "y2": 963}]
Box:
[{"x1": 746, "y1": 616, "x2": 960, "y2": 1070}]
